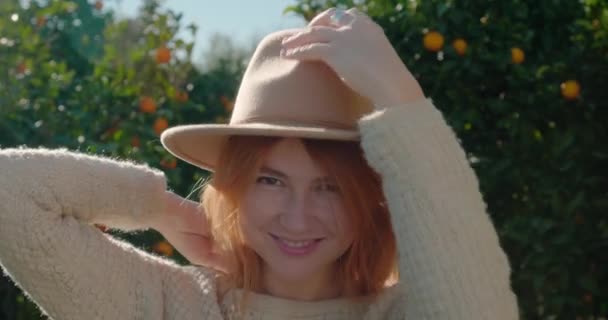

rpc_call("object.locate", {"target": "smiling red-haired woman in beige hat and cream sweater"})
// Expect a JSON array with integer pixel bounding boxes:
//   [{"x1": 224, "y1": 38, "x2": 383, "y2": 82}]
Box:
[{"x1": 0, "y1": 8, "x2": 518, "y2": 319}]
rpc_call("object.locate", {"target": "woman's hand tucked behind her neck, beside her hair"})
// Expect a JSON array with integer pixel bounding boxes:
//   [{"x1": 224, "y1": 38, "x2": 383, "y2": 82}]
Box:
[{"x1": 150, "y1": 190, "x2": 229, "y2": 272}]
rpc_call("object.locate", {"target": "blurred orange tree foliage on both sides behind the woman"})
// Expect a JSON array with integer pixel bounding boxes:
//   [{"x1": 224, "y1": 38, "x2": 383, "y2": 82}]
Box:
[{"x1": 0, "y1": 0, "x2": 608, "y2": 319}]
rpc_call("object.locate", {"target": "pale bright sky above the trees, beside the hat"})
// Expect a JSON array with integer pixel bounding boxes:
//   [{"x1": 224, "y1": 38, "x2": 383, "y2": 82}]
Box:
[{"x1": 106, "y1": 0, "x2": 306, "y2": 59}]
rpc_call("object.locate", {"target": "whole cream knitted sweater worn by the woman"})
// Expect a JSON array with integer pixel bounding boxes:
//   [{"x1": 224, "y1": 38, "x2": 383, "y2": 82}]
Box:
[{"x1": 0, "y1": 99, "x2": 518, "y2": 320}]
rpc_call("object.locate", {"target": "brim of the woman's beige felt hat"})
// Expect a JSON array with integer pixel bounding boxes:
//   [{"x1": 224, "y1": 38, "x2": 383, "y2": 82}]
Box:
[{"x1": 160, "y1": 123, "x2": 360, "y2": 171}]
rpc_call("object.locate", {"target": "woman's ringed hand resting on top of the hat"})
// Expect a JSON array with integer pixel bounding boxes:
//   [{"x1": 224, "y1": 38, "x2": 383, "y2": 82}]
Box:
[{"x1": 281, "y1": 8, "x2": 425, "y2": 108}]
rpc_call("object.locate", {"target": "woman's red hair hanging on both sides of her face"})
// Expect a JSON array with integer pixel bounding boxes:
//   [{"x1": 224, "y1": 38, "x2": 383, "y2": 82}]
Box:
[{"x1": 201, "y1": 136, "x2": 398, "y2": 304}]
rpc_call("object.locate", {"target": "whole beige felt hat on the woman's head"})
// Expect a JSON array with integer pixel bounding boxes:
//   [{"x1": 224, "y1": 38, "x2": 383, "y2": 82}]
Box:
[{"x1": 160, "y1": 29, "x2": 373, "y2": 171}]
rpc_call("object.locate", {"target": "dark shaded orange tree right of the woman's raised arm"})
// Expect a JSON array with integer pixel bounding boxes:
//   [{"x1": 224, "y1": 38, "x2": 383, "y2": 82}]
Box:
[{"x1": 286, "y1": 0, "x2": 608, "y2": 319}]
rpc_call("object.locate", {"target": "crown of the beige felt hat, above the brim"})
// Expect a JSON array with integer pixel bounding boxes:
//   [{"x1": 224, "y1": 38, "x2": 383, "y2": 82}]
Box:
[{"x1": 230, "y1": 29, "x2": 372, "y2": 130}]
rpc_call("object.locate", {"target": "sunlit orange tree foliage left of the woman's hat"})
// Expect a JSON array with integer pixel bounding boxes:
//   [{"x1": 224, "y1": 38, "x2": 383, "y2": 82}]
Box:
[{"x1": 0, "y1": 0, "x2": 244, "y2": 319}]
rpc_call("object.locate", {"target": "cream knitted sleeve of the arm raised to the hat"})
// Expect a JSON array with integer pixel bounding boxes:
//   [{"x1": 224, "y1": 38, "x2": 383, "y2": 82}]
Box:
[{"x1": 359, "y1": 98, "x2": 518, "y2": 320}]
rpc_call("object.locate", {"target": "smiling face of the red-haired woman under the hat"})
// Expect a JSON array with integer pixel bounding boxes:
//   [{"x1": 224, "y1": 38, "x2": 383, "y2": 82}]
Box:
[{"x1": 240, "y1": 138, "x2": 353, "y2": 281}]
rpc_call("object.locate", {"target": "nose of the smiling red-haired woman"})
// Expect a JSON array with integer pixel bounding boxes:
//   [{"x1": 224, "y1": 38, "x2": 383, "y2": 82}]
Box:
[{"x1": 279, "y1": 192, "x2": 312, "y2": 234}]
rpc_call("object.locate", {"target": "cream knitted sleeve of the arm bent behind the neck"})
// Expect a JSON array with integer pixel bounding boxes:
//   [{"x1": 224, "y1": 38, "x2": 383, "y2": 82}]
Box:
[{"x1": 0, "y1": 148, "x2": 219, "y2": 319}]
